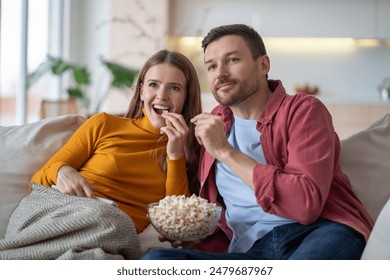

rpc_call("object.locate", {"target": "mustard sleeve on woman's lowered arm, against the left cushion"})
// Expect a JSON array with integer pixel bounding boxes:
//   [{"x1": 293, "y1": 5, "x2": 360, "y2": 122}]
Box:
[{"x1": 31, "y1": 114, "x2": 104, "y2": 187}]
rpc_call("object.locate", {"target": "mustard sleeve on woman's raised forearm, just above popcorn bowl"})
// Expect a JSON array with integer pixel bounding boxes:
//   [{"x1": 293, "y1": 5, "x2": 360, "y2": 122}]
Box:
[{"x1": 165, "y1": 157, "x2": 189, "y2": 195}]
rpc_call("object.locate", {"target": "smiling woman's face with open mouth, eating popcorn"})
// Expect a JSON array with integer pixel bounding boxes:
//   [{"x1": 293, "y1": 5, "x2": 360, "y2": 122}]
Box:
[{"x1": 140, "y1": 63, "x2": 187, "y2": 128}]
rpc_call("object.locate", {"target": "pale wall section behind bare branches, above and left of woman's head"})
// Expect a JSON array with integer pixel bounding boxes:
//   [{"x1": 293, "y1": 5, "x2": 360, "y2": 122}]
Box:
[{"x1": 103, "y1": 0, "x2": 168, "y2": 113}]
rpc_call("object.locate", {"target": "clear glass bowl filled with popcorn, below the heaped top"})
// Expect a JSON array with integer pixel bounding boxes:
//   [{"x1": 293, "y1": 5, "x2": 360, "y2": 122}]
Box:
[{"x1": 147, "y1": 202, "x2": 222, "y2": 242}]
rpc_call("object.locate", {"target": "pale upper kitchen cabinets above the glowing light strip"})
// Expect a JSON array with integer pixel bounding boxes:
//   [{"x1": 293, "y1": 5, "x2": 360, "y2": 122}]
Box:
[{"x1": 170, "y1": 0, "x2": 390, "y2": 38}]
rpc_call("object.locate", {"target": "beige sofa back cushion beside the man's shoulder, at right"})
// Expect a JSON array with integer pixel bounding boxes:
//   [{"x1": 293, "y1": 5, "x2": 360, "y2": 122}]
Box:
[{"x1": 340, "y1": 114, "x2": 390, "y2": 221}]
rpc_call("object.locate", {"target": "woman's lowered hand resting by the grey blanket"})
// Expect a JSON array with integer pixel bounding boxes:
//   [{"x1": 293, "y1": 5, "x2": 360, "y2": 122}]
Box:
[{"x1": 56, "y1": 165, "x2": 95, "y2": 197}]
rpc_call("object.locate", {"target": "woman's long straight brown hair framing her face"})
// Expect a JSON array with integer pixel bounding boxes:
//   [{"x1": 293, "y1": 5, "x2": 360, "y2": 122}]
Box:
[{"x1": 125, "y1": 50, "x2": 202, "y2": 193}]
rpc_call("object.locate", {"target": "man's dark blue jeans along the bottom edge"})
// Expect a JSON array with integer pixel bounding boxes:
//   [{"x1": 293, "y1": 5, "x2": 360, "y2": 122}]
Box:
[{"x1": 141, "y1": 219, "x2": 366, "y2": 260}]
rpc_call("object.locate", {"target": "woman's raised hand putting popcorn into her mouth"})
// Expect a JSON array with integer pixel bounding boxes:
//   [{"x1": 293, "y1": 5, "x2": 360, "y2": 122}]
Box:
[{"x1": 161, "y1": 113, "x2": 189, "y2": 159}]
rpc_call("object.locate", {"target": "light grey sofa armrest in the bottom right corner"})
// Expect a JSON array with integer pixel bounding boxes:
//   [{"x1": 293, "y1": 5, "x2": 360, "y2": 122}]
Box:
[{"x1": 361, "y1": 199, "x2": 390, "y2": 260}]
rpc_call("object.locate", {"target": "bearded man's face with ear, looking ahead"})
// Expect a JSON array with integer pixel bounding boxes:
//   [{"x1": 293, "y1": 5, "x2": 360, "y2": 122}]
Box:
[{"x1": 204, "y1": 35, "x2": 262, "y2": 106}]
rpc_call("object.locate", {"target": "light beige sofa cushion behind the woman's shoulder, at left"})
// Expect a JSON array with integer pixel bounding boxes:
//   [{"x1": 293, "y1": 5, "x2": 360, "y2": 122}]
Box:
[{"x1": 0, "y1": 115, "x2": 85, "y2": 239}]
